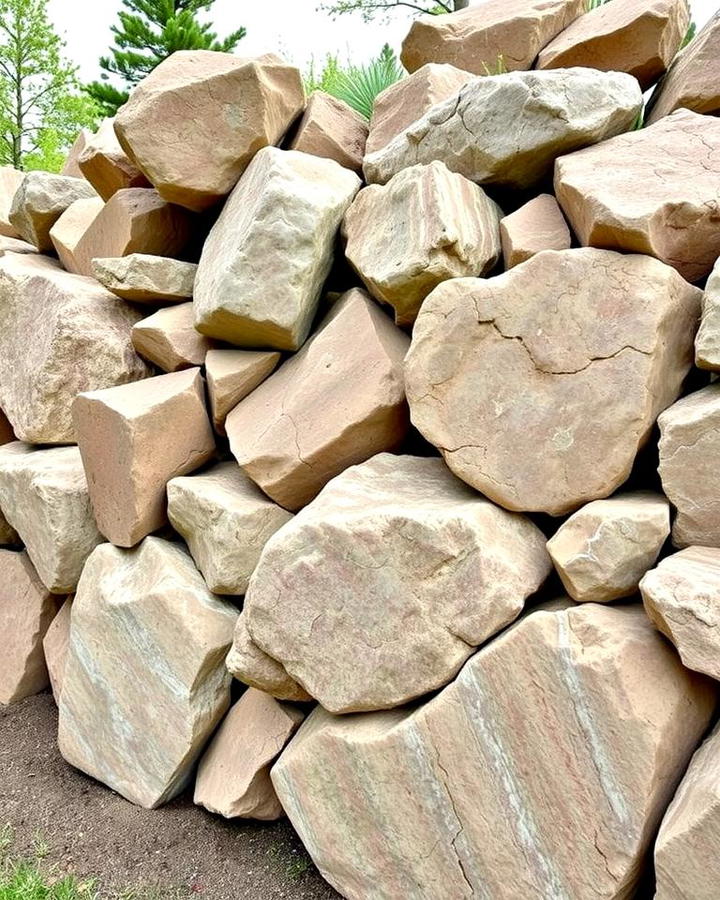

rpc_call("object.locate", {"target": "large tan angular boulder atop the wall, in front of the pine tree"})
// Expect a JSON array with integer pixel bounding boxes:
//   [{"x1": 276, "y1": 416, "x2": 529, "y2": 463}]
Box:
[{"x1": 115, "y1": 50, "x2": 305, "y2": 211}]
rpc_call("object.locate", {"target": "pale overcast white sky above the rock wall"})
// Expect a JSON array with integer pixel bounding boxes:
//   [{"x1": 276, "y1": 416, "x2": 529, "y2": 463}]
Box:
[{"x1": 49, "y1": 0, "x2": 719, "y2": 81}]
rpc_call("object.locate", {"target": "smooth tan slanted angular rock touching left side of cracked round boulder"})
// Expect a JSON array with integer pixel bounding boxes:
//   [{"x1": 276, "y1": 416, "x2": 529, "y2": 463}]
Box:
[{"x1": 225, "y1": 289, "x2": 409, "y2": 510}]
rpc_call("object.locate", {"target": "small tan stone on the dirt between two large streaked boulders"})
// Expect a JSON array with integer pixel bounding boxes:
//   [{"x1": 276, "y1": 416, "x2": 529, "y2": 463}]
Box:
[{"x1": 195, "y1": 688, "x2": 305, "y2": 822}]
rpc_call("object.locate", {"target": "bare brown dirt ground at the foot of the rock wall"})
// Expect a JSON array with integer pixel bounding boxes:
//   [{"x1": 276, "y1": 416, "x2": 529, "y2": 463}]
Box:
[{"x1": 0, "y1": 693, "x2": 339, "y2": 900}]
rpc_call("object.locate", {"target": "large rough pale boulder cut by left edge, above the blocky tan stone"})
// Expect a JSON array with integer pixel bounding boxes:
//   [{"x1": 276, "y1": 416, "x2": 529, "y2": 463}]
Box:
[{"x1": 0, "y1": 254, "x2": 150, "y2": 444}]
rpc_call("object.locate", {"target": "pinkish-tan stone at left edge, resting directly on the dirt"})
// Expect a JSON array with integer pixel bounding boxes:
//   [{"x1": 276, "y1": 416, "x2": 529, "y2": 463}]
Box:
[{"x1": 0, "y1": 550, "x2": 57, "y2": 705}]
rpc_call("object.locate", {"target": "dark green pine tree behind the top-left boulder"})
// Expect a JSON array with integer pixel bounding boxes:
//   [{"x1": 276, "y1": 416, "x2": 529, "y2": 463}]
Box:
[{"x1": 87, "y1": 0, "x2": 246, "y2": 116}]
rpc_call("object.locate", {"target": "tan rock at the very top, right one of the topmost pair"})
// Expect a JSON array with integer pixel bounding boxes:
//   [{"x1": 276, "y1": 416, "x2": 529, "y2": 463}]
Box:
[{"x1": 537, "y1": 0, "x2": 690, "y2": 90}]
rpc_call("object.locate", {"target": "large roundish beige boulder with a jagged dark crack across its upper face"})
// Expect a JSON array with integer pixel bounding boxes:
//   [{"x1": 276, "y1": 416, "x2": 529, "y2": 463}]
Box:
[{"x1": 405, "y1": 249, "x2": 702, "y2": 516}]
